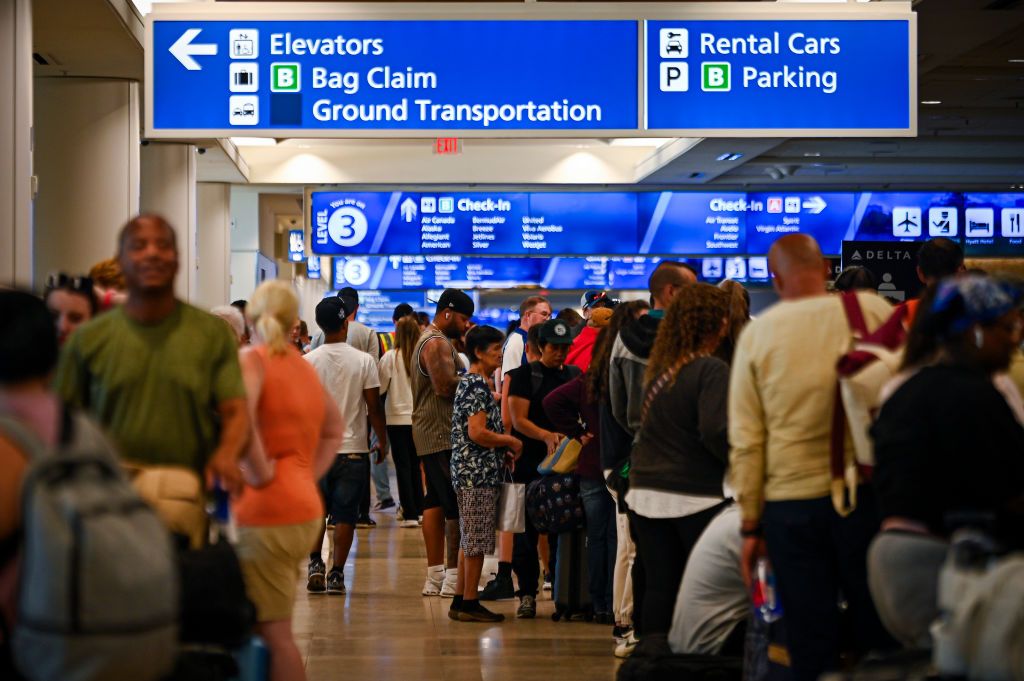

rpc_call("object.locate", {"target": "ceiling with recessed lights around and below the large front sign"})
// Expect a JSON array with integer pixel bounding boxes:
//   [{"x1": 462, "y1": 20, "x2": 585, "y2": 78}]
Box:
[{"x1": 33, "y1": 0, "x2": 1024, "y2": 188}]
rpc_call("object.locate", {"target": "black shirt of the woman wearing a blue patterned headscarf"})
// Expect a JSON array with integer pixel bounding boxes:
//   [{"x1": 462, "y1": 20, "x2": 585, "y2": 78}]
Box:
[{"x1": 871, "y1": 366, "x2": 1024, "y2": 546}]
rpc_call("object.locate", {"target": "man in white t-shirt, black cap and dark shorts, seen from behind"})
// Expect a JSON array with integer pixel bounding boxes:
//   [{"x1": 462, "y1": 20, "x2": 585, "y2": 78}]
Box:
[{"x1": 305, "y1": 298, "x2": 387, "y2": 594}]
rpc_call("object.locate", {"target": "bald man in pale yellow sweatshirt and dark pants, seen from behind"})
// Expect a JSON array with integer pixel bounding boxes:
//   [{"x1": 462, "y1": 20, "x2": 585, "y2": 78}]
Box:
[{"x1": 729, "y1": 235, "x2": 892, "y2": 681}]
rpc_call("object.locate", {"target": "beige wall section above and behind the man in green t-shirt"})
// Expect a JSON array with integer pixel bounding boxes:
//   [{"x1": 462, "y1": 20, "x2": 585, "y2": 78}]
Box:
[{"x1": 33, "y1": 78, "x2": 139, "y2": 283}]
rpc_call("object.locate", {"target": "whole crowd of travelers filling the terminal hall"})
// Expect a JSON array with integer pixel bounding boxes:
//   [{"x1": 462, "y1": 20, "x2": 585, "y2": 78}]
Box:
[{"x1": 0, "y1": 215, "x2": 1024, "y2": 681}]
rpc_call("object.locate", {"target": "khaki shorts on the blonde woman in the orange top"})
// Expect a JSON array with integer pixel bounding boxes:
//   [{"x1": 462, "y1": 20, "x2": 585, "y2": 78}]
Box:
[{"x1": 236, "y1": 518, "x2": 323, "y2": 622}]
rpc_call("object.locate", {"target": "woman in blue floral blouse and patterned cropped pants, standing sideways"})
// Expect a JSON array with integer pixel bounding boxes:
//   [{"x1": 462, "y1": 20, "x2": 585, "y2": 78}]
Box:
[{"x1": 449, "y1": 327, "x2": 522, "y2": 622}]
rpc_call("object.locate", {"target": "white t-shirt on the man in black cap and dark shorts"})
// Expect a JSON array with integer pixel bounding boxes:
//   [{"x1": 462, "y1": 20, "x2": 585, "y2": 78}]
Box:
[{"x1": 305, "y1": 343, "x2": 381, "y2": 454}]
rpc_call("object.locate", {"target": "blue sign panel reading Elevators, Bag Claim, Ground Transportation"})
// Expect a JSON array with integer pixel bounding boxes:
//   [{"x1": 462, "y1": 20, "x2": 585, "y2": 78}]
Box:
[{"x1": 146, "y1": 17, "x2": 639, "y2": 136}]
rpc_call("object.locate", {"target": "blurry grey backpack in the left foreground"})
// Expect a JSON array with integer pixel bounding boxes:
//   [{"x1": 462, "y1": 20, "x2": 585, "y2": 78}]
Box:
[{"x1": 0, "y1": 411, "x2": 178, "y2": 681}]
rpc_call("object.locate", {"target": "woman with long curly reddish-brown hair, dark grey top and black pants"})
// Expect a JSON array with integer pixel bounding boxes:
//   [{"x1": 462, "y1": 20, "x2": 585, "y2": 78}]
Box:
[{"x1": 626, "y1": 284, "x2": 729, "y2": 649}]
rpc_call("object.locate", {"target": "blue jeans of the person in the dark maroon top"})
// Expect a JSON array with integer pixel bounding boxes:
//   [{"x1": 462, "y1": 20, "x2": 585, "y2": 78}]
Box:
[{"x1": 580, "y1": 479, "x2": 617, "y2": 612}]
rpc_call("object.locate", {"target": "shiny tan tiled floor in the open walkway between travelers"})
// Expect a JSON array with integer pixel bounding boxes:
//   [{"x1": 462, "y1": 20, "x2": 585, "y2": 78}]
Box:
[{"x1": 295, "y1": 513, "x2": 617, "y2": 681}]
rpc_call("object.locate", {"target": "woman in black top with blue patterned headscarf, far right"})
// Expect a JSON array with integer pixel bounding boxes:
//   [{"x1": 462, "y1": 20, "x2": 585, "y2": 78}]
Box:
[{"x1": 868, "y1": 275, "x2": 1024, "y2": 648}]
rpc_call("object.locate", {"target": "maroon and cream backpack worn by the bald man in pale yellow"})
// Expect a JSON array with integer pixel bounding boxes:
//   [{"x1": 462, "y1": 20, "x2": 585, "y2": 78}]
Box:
[{"x1": 829, "y1": 291, "x2": 906, "y2": 516}]
